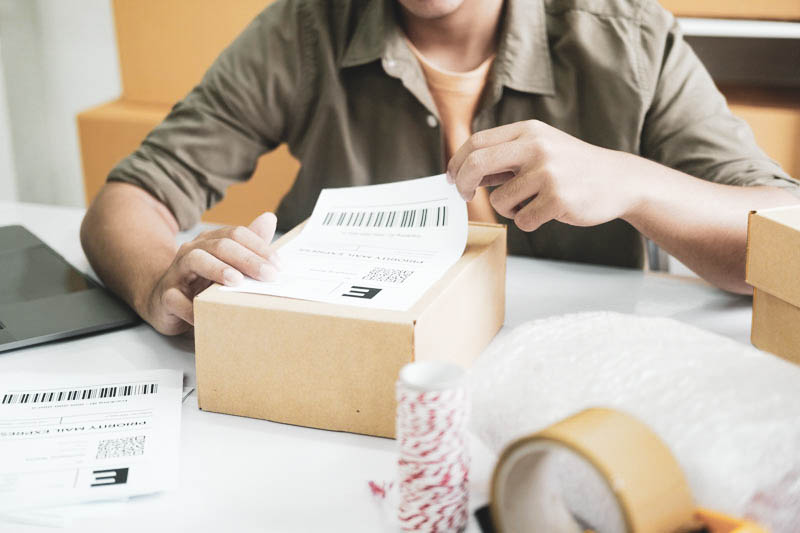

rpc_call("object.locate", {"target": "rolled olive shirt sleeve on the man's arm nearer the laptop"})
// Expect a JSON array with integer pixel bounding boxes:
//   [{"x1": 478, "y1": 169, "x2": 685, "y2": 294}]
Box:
[{"x1": 108, "y1": 1, "x2": 301, "y2": 229}]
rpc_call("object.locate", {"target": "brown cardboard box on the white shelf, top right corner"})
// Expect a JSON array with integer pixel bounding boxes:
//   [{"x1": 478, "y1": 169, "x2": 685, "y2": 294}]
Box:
[{"x1": 661, "y1": 0, "x2": 800, "y2": 20}]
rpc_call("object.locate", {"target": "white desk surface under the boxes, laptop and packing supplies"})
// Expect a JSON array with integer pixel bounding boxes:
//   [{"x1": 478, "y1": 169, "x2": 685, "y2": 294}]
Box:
[{"x1": 0, "y1": 202, "x2": 751, "y2": 533}]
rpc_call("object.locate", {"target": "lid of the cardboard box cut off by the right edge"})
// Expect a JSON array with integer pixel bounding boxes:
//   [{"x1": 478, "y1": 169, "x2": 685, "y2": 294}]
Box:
[{"x1": 745, "y1": 206, "x2": 800, "y2": 307}]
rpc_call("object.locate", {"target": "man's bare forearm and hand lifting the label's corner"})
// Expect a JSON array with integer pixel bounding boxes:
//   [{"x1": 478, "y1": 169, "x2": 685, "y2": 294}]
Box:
[{"x1": 447, "y1": 120, "x2": 797, "y2": 294}]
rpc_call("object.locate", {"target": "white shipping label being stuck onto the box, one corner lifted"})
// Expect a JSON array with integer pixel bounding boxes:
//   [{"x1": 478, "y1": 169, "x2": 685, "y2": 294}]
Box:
[{"x1": 223, "y1": 174, "x2": 468, "y2": 311}]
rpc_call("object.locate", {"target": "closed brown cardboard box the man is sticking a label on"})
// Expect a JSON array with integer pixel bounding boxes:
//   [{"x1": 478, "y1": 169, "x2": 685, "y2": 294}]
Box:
[{"x1": 194, "y1": 223, "x2": 506, "y2": 437}]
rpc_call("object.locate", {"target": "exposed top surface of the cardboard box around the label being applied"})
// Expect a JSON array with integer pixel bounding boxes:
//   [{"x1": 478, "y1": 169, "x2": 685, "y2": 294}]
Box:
[{"x1": 195, "y1": 222, "x2": 506, "y2": 324}]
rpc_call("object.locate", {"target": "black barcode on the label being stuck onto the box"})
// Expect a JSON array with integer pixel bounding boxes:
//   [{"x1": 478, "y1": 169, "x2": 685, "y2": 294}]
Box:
[{"x1": 322, "y1": 205, "x2": 447, "y2": 228}]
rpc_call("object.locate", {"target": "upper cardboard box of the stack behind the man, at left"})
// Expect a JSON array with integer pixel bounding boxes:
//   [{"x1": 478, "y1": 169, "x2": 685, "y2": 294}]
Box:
[{"x1": 113, "y1": 0, "x2": 271, "y2": 105}]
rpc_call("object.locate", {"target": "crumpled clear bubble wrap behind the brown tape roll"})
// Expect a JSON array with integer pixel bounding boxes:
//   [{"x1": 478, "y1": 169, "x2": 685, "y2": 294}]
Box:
[{"x1": 469, "y1": 312, "x2": 800, "y2": 533}]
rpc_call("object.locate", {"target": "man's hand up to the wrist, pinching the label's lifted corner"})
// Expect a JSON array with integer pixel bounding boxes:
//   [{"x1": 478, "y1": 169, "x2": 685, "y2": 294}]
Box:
[{"x1": 447, "y1": 120, "x2": 635, "y2": 231}]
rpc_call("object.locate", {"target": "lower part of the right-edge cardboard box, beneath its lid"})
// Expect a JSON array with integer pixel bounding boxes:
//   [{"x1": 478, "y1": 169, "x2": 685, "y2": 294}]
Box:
[{"x1": 750, "y1": 289, "x2": 800, "y2": 365}]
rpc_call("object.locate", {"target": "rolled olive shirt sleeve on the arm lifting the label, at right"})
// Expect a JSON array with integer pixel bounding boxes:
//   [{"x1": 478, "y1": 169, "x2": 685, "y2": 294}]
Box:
[{"x1": 640, "y1": 2, "x2": 800, "y2": 198}]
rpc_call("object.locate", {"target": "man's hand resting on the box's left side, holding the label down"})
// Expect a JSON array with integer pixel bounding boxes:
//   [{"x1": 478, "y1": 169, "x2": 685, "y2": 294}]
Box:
[{"x1": 142, "y1": 213, "x2": 280, "y2": 335}]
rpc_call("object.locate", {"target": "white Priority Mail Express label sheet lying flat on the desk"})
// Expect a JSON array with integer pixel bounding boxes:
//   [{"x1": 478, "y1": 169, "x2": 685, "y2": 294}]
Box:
[{"x1": 0, "y1": 370, "x2": 183, "y2": 515}]
